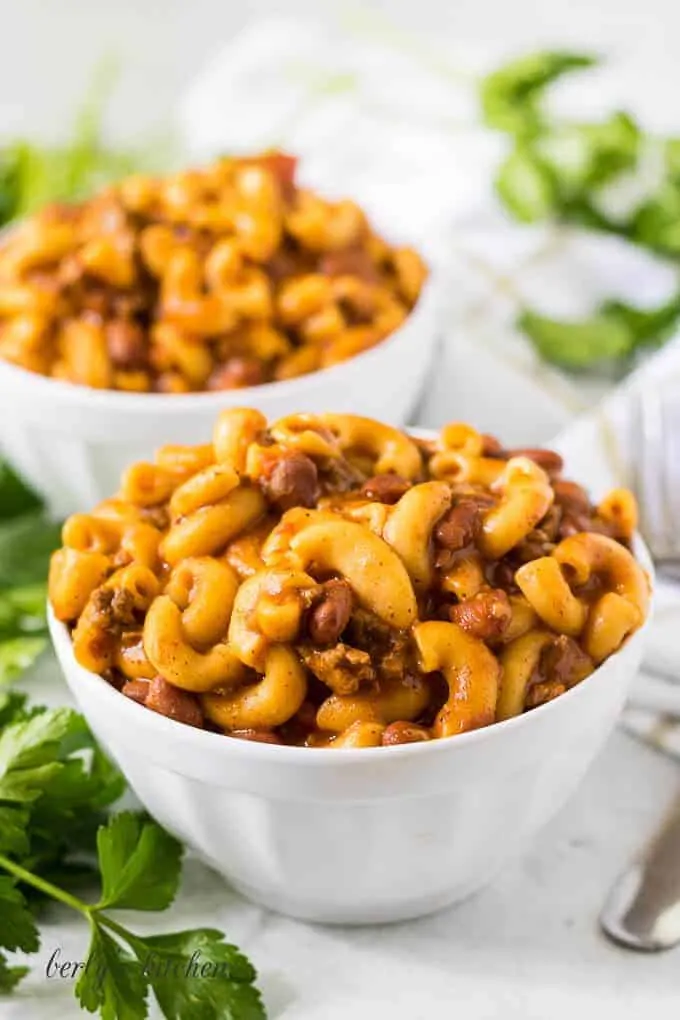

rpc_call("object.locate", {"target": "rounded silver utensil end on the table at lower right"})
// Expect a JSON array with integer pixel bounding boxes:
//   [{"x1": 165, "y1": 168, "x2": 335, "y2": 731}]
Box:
[{"x1": 599, "y1": 802, "x2": 680, "y2": 952}]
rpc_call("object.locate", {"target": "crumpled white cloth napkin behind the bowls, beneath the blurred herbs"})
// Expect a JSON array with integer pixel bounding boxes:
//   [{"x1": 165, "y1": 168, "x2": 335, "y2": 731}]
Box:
[{"x1": 179, "y1": 17, "x2": 680, "y2": 741}]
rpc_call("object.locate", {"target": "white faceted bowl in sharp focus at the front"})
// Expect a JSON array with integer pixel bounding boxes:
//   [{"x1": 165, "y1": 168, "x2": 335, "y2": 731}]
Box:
[{"x1": 45, "y1": 544, "x2": 651, "y2": 924}]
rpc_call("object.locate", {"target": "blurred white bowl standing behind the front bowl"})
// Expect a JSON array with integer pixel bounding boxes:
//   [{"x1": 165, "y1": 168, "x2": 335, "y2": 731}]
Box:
[{"x1": 0, "y1": 272, "x2": 444, "y2": 516}]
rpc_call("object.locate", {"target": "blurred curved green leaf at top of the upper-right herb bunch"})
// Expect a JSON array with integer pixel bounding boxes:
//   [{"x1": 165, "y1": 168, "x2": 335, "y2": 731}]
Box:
[{"x1": 480, "y1": 51, "x2": 597, "y2": 136}]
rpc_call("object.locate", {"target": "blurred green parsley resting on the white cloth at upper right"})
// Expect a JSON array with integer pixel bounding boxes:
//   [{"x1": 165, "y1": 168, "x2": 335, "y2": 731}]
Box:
[{"x1": 480, "y1": 51, "x2": 680, "y2": 370}]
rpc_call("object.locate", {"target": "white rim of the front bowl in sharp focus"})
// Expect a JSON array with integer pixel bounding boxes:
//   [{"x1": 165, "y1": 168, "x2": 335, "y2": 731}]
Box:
[{"x1": 48, "y1": 538, "x2": 653, "y2": 768}]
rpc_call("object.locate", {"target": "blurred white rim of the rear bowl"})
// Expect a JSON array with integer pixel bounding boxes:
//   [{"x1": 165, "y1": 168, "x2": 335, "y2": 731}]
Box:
[{"x1": 0, "y1": 265, "x2": 442, "y2": 418}]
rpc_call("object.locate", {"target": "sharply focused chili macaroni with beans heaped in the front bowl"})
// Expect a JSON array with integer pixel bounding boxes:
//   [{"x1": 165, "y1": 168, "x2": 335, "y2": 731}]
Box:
[{"x1": 47, "y1": 410, "x2": 649, "y2": 749}]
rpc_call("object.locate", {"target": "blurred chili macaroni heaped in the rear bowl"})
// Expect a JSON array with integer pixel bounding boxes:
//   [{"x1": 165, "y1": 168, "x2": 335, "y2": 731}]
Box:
[{"x1": 0, "y1": 153, "x2": 427, "y2": 394}]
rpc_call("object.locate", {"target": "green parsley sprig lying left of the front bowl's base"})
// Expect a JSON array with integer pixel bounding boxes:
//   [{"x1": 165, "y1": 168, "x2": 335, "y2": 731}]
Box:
[{"x1": 0, "y1": 692, "x2": 265, "y2": 1020}]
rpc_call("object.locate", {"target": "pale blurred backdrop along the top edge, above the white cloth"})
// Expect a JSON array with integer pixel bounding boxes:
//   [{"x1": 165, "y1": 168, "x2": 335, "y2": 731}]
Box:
[{"x1": 0, "y1": 0, "x2": 680, "y2": 142}]
